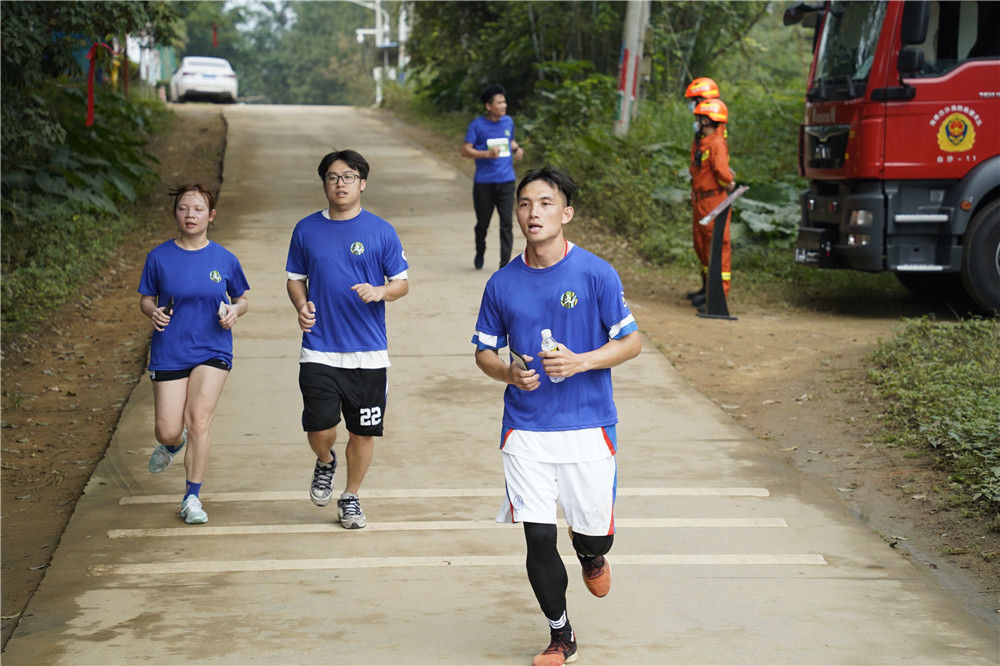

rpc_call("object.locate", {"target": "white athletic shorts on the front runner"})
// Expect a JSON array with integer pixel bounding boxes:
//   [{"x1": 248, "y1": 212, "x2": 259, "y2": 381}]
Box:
[{"x1": 497, "y1": 453, "x2": 618, "y2": 536}]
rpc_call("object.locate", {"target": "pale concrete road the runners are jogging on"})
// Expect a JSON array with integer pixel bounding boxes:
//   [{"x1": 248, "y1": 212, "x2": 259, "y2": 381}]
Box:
[{"x1": 3, "y1": 106, "x2": 998, "y2": 666}]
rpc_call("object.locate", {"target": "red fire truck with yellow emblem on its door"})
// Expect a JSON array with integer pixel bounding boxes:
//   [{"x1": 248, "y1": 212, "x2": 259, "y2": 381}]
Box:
[{"x1": 784, "y1": 0, "x2": 1000, "y2": 313}]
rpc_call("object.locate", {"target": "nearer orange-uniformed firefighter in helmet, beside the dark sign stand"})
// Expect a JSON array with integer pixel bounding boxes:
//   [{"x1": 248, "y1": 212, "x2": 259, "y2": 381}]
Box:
[{"x1": 689, "y1": 99, "x2": 736, "y2": 308}]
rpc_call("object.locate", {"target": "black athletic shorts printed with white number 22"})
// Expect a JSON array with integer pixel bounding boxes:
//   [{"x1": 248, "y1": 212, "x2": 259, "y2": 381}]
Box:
[{"x1": 299, "y1": 363, "x2": 388, "y2": 437}]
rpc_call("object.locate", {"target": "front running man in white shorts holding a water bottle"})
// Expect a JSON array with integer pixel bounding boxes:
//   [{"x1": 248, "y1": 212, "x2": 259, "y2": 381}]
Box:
[{"x1": 472, "y1": 166, "x2": 642, "y2": 666}]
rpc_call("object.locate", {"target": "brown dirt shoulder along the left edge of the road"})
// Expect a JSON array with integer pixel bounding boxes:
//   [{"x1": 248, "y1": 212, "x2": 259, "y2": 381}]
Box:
[{"x1": 0, "y1": 105, "x2": 226, "y2": 646}]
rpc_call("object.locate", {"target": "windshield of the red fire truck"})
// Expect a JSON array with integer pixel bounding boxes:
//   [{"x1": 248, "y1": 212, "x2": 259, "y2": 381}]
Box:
[{"x1": 807, "y1": 0, "x2": 886, "y2": 101}]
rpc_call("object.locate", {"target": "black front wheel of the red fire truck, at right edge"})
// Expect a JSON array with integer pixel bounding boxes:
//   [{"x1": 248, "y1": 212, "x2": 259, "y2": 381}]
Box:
[{"x1": 962, "y1": 199, "x2": 1000, "y2": 314}]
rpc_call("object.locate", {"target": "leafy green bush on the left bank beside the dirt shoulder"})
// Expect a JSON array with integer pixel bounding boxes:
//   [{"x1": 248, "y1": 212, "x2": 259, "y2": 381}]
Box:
[{"x1": 0, "y1": 87, "x2": 169, "y2": 333}]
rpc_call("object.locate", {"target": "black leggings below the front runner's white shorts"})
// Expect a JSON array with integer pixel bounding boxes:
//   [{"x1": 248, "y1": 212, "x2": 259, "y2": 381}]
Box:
[{"x1": 524, "y1": 523, "x2": 615, "y2": 620}]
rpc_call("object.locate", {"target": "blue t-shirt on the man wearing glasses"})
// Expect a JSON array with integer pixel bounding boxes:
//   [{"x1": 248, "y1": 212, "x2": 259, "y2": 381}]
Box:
[{"x1": 285, "y1": 210, "x2": 409, "y2": 353}]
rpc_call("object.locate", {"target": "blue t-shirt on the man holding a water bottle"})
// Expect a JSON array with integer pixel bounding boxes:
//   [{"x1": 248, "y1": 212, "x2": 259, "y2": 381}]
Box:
[{"x1": 472, "y1": 246, "x2": 638, "y2": 432}]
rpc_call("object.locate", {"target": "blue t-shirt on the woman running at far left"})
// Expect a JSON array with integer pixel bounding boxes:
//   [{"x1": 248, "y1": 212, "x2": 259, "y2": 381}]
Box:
[{"x1": 139, "y1": 240, "x2": 250, "y2": 371}]
